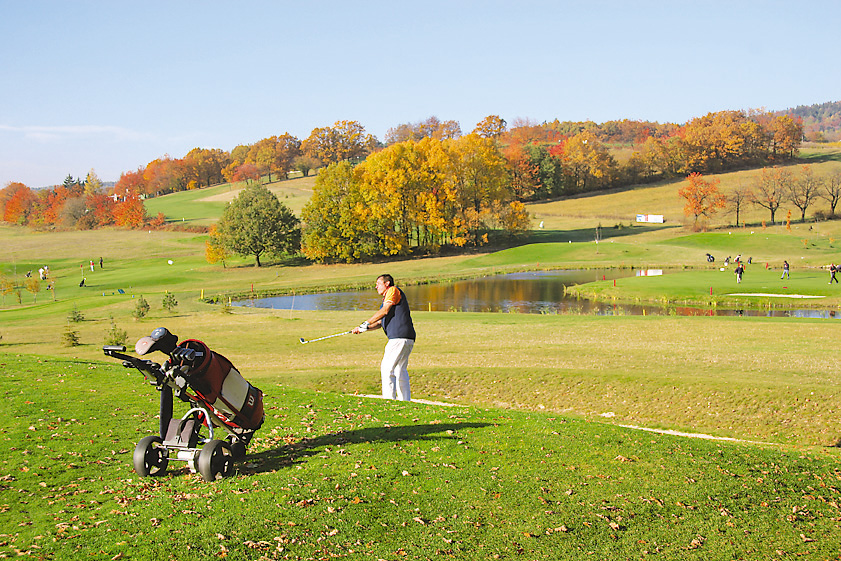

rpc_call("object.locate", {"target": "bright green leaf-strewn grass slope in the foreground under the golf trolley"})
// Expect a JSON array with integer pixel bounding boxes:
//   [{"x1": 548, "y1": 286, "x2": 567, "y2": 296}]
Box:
[{"x1": 0, "y1": 355, "x2": 841, "y2": 559}]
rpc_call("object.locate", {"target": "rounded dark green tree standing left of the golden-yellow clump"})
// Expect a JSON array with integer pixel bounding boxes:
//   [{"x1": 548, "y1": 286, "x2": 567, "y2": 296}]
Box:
[{"x1": 217, "y1": 184, "x2": 300, "y2": 267}]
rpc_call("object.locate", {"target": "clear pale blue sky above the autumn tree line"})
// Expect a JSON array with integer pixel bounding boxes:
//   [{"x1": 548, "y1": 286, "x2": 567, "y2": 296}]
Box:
[{"x1": 0, "y1": 0, "x2": 841, "y2": 188}]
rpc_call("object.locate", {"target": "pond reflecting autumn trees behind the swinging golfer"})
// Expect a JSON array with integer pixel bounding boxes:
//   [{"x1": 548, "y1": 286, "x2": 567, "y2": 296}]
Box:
[{"x1": 234, "y1": 269, "x2": 838, "y2": 318}]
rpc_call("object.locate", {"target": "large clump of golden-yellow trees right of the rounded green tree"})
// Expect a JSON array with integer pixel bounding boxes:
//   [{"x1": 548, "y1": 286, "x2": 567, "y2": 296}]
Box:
[{"x1": 302, "y1": 134, "x2": 529, "y2": 262}]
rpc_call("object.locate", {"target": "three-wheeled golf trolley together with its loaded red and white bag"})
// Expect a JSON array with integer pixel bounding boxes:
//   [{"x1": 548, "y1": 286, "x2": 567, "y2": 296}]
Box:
[{"x1": 102, "y1": 327, "x2": 264, "y2": 481}]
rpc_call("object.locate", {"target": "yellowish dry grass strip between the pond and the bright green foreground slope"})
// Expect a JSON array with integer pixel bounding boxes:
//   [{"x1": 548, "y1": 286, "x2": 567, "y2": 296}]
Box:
[{"x1": 0, "y1": 308, "x2": 841, "y2": 446}]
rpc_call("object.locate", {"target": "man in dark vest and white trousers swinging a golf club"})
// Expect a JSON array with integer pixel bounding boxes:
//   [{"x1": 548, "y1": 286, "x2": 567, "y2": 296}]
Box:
[{"x1": 353, "y1": 275, "x2": 415, "y2": 401}]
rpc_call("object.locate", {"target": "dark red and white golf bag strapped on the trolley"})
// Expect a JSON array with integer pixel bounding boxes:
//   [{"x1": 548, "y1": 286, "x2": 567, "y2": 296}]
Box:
[{"x1": 178, "y1": 339, "x2": 263, "y2": 429}]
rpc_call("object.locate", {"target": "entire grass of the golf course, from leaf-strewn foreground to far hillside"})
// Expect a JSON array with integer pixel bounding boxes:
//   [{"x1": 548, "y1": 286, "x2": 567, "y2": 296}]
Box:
[{"x1": 0, "y1": 160, "x2": 841, "y2": 559}]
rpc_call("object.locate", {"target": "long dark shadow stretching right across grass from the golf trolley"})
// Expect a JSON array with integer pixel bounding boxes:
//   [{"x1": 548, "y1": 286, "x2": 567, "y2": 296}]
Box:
[{"x1": 243, "y1": 423, "x2": 491, "y2": 473}]
